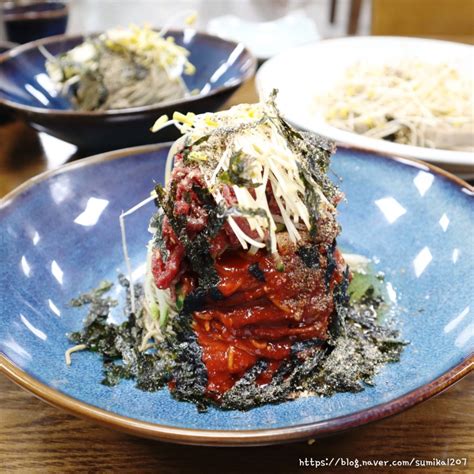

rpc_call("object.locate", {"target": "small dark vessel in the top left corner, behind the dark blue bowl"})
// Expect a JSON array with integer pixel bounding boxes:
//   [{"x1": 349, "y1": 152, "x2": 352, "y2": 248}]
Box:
[{"x1": 1, "y1": 0, "x2": 69, "y2": 44}]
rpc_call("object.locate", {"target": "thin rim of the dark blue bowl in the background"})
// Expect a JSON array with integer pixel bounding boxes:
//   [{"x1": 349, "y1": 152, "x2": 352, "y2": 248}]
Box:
[{"x1": 0, "y1": 29, "x2": 257, "y2": 117}]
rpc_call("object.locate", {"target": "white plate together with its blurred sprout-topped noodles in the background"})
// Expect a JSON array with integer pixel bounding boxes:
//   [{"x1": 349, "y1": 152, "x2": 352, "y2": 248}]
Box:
[{"x1": 256, "y1": 36, "x2": 474, "y2": 179}]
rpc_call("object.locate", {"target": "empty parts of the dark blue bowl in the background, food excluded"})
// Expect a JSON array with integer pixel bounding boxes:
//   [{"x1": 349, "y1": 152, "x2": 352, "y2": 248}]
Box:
[{"x1": 0, "y1": 30, "x2": 256, "y2": 151}]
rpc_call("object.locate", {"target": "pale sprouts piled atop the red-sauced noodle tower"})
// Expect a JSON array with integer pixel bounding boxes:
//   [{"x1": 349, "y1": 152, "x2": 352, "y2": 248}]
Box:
[{"x1": 151, "y1": 96, "x2": 335, "y2": 253}]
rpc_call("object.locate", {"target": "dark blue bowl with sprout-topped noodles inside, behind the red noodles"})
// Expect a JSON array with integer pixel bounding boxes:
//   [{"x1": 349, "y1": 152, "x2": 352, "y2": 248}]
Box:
[{"x1": 0, "y1": 21, "x2": 256, "y2": 151}]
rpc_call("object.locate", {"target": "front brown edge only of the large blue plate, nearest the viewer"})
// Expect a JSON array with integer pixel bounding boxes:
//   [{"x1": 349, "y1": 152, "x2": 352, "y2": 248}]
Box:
[{"x1": 0, "y1": 354, "x2": 474, "y2": 447}]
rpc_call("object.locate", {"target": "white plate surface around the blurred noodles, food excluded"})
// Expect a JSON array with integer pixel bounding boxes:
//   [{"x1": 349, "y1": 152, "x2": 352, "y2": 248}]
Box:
[{"x1": 256, "y1": 36, "x2": 474, "y2": 178}]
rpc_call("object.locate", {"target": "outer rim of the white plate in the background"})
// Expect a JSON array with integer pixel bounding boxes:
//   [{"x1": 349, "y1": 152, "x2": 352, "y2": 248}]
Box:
[{"x1": 255, "y1": 36, "x2": 474, "y2": 170}]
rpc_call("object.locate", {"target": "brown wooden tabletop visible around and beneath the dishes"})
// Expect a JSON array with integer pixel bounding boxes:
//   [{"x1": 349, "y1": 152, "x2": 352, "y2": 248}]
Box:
[{"x1": 0, "y1": 79, "x2": 474, "y2": 474}]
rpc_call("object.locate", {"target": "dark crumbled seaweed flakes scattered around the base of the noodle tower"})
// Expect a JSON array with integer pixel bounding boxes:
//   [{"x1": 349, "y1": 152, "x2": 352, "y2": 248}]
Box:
[{"x1": 69, "y1": 272, "x2": 406, "y2": 411}]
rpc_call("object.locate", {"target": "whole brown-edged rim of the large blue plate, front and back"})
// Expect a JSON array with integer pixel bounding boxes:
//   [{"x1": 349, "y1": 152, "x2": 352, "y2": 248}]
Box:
[{"x1": 0, "y1": 143, "x2": 474, "y2": 446}]
